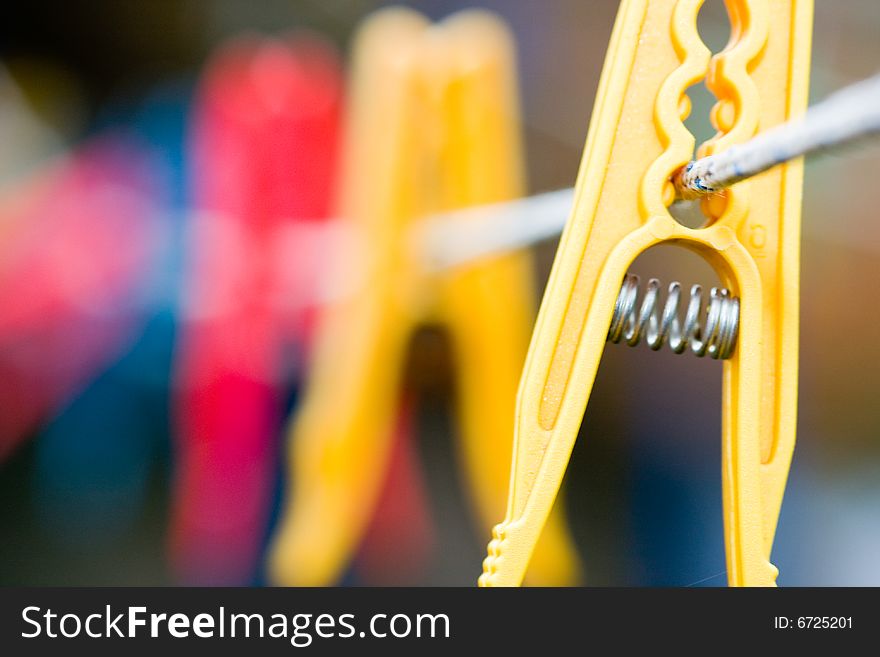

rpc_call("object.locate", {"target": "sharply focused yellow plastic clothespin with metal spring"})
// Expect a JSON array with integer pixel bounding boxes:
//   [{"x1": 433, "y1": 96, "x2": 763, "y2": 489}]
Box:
[{"x1": 480, "y1": 0, "x2": 812, "y2": 586}]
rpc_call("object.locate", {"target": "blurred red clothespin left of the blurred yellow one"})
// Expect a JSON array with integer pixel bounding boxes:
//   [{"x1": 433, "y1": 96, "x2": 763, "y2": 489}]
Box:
[{"x1": 171, "y1": 37, "x2": 343, "y2": 585}]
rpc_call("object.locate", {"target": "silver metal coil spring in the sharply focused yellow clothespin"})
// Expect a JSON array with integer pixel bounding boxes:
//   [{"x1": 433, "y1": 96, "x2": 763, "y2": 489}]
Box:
[{"x1": 608, "y1": 274, "x2": 739, "y2": 360}]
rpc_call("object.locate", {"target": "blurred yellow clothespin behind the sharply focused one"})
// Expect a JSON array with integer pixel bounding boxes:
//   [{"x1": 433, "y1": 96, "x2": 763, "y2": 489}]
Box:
[{"x1": 270, "y1": 8, "x2": 577, "y2": 585}]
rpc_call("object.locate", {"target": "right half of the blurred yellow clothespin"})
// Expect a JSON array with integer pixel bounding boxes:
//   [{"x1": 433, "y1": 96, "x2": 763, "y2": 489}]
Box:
[{"x1": 438, "y1": 11, "x2": 580, "y2": 586}]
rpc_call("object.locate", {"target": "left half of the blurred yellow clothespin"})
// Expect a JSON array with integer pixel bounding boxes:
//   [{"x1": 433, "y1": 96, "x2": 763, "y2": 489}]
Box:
[{"x1": 269, "y1": 11, "x2": 430, "y2": 586}]
